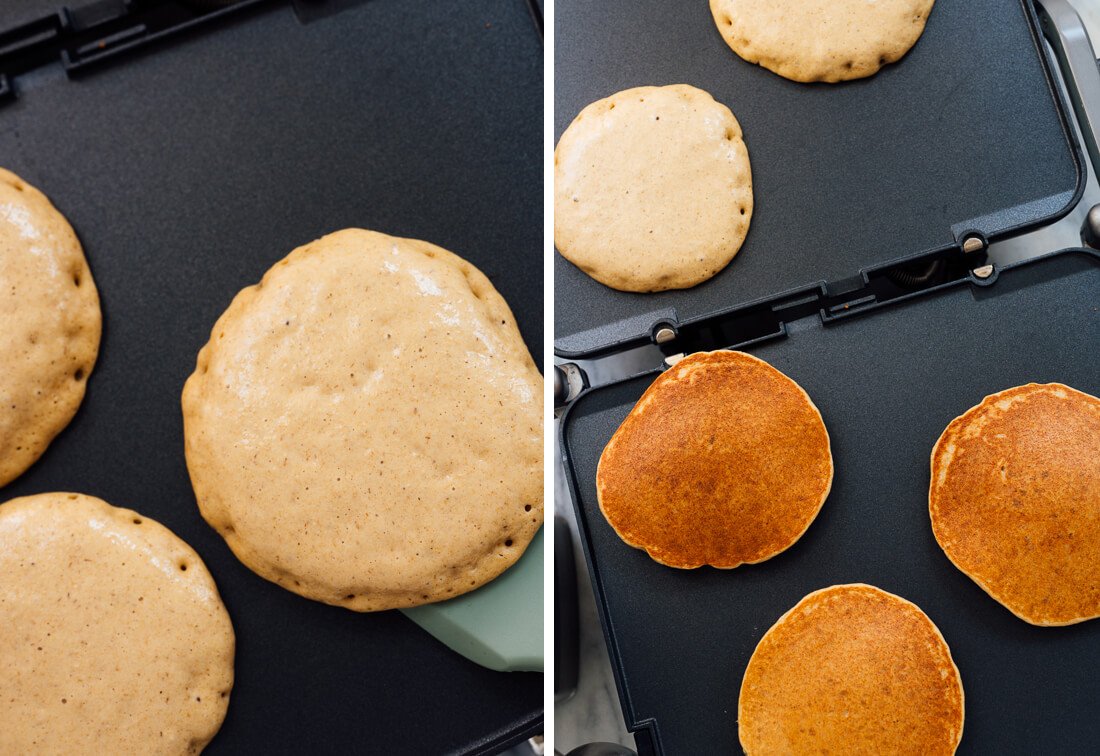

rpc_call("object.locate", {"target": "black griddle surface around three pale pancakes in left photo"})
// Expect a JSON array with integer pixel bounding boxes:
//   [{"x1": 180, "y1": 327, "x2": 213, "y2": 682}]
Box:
[{"x1": 0, "y1": 0, "x2": 543, "y2": 754}]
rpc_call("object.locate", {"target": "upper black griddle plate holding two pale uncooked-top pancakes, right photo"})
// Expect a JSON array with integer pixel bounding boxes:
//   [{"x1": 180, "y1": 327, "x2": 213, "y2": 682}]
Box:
[{"x1": 554, "y1": 0, "x2": 1084, "y2": 357}]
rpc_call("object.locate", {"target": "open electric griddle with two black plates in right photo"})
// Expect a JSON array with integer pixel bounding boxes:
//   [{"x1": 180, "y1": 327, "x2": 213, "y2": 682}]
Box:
[{"x1": 554, "y1": 0, "x2": 1100, "y2": 756}]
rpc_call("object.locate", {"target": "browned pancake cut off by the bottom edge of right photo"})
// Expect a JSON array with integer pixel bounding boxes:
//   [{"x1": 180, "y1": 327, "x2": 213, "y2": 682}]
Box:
[{"x1": 737, "y1": 583, "x2": 964, "y2": 756}]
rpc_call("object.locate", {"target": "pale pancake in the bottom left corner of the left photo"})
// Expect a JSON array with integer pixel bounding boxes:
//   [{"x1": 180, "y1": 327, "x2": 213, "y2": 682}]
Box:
[{"x1": 0, "y1": 493, "x2": 234, "y2": 754}]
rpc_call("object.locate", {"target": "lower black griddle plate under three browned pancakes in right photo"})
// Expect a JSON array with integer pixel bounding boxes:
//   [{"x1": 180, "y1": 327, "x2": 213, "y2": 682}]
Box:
[{"x1": 562, "y1": 252, "x2": 1100, "y2": 755}]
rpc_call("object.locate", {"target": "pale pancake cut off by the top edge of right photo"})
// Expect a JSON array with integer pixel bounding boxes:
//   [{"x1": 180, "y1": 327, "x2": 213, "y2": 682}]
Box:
[{"x1": 711, "y1": 0, "x2": 934, "y2": 83}]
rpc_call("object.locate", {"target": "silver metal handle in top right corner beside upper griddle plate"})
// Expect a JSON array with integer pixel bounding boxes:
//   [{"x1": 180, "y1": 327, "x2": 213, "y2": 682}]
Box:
[{"x1": 1036, "y1": 0, "x2": 1100, "y2": 180}]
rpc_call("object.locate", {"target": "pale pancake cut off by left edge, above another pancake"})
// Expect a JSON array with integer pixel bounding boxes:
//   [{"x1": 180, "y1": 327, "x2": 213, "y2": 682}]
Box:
[{"x1": 0, "y1": 168, "x2": 101, "y2": 485}]
